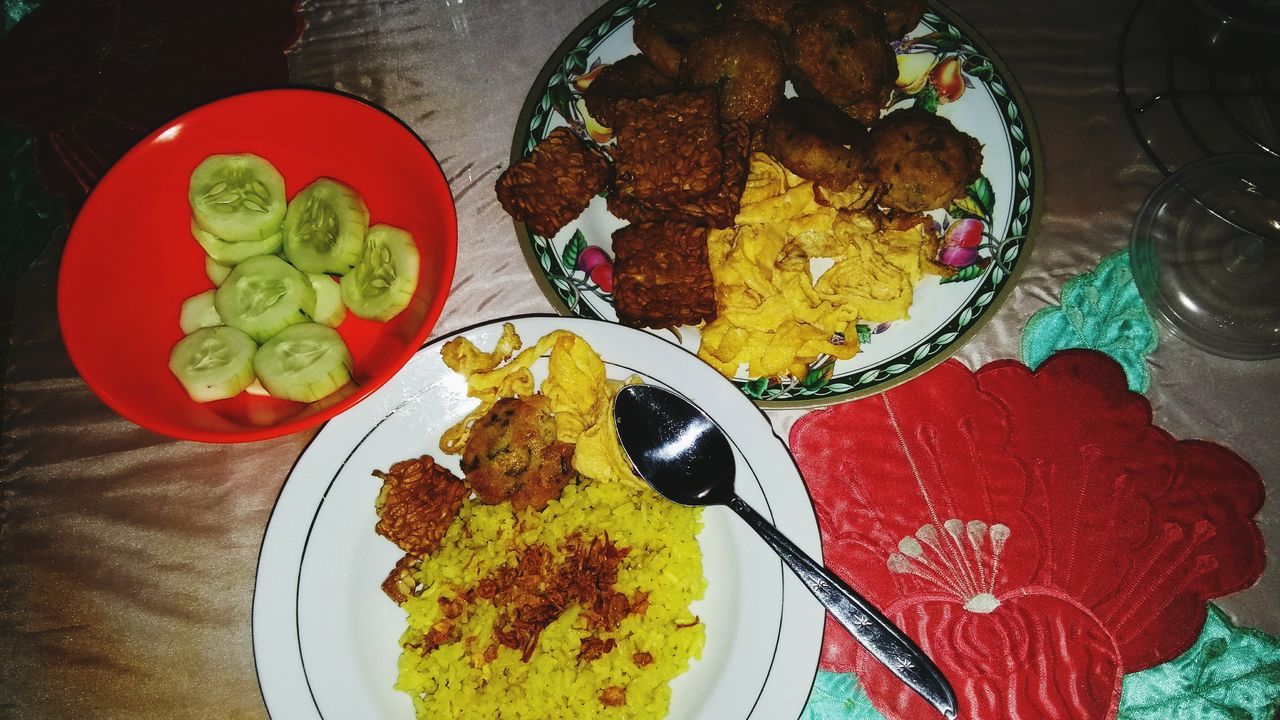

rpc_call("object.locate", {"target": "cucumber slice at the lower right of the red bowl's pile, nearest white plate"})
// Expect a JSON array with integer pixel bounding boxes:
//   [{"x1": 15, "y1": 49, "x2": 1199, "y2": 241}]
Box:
[{"x1": 253, "y1": 323, "x2": 352, "y2": 402}]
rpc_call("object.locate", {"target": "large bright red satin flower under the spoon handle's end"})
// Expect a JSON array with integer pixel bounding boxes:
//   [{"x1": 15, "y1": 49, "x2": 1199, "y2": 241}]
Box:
[{"x1": 791, "y1": 351, "x2": 1265, "y2": 719}]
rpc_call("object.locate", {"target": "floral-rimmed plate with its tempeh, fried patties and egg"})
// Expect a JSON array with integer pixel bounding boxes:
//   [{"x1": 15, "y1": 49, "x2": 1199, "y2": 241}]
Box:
[{"x1": 495, "y1": 0, "x2": 1043, "y2": 407}]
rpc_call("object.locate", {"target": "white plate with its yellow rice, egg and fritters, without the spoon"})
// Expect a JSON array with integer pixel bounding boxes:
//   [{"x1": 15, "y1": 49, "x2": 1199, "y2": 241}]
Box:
[{"x1": 253, "y1": 316, "x2": 824, "y2": 720}]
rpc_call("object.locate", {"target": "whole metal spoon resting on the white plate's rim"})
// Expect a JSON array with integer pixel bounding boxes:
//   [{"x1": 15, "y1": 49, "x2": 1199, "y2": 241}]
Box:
[{"x1": 613, "y1": 384, "x2": 956, "y2": 717}]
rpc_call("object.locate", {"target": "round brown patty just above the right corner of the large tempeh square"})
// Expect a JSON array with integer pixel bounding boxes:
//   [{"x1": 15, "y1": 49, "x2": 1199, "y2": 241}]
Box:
[{"x1": 680, "y1": 22, "x2": 786, "y2": 123}]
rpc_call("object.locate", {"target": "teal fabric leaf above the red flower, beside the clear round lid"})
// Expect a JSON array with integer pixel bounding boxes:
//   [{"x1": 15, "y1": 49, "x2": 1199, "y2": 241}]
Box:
[{"x1": 1021, "y1": 250, "x2": 1160, "y2": 392}]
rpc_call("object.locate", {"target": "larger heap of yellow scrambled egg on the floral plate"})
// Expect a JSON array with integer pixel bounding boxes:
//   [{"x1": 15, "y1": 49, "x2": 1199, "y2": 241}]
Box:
[{"x1": 698, "y1": 152, "x2": 937, "y2": 377}]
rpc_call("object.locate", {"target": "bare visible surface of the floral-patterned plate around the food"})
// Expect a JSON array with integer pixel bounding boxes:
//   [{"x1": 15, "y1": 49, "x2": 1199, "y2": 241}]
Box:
[{"x1": 511, "y1": 0, "x2": 1043, "y2": 407}]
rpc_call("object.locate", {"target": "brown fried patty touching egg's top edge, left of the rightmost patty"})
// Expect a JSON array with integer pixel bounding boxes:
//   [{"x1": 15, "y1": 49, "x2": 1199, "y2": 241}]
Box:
[{"x1": 764, "y1": 97, "x2": 872, "y2": 191}]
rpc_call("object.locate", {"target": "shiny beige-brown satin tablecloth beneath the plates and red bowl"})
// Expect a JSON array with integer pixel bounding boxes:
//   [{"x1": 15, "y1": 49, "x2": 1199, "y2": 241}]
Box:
[{"x1": 0, "y1": 0, "x2": 1280, "y2": 720}]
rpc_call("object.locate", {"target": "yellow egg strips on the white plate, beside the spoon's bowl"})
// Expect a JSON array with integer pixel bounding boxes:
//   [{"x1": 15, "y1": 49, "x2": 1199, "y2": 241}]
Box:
[{"x1": 440, "y1": 323, "x2": 648, "y2": 487}]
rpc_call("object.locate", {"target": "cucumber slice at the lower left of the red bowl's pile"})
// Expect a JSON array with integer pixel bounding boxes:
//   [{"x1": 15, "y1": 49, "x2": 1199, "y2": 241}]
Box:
[{"x1": 169, "y1": 325, "x2": 257, "y2": 402}]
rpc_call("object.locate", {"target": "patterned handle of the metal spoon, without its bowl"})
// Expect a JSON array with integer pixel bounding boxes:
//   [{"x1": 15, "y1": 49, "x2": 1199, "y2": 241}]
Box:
[{"x1": 728, "y1": 495, "x2": 956, "y2": 717}]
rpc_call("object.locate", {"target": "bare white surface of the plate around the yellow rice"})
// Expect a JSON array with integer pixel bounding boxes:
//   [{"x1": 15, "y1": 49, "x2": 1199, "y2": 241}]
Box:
[{"x1": 253, "y1": 316, "x2": 824, "y2": 720}]
